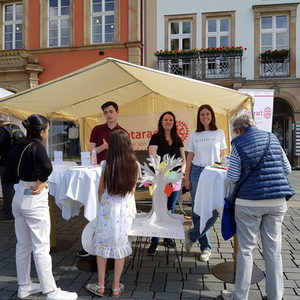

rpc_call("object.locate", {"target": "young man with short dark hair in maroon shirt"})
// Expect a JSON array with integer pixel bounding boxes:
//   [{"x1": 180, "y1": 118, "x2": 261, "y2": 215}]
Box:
[{"x1": 90, "y1": 101, "x2": 127, "y2": 164}]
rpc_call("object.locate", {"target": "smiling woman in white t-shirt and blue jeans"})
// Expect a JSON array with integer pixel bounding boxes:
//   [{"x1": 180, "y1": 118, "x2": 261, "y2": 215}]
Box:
[{"x1": 184, "y1": 104, "x2": 227, "y2": 261}]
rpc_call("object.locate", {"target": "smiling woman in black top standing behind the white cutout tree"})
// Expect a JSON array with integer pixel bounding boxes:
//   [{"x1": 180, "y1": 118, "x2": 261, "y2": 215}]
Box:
[{"x1": 148, "y1": 111, "x2": 185, "y2": 255}]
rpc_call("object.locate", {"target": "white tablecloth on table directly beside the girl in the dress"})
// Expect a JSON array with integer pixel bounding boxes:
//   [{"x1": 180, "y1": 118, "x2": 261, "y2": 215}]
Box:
[{"x1": 56, "y1": 165, "x2": 102, "y2": 221}]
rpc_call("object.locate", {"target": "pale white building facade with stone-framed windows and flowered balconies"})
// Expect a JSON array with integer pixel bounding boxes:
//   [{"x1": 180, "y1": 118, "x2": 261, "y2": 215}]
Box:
[{"x1": 144, "y1": 0, "x2": 300, "y2": 166}]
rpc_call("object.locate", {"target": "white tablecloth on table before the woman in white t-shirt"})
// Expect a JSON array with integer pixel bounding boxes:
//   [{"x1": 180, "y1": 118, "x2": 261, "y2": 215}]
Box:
[{"x1": 194, "y1": 167, "x2": 228, "y2": 232}]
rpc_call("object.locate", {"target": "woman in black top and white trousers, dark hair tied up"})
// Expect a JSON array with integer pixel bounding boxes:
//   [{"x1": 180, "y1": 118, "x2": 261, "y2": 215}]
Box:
[{"x1": 4, "y1": 115, "x2": 78, "y2": 300}]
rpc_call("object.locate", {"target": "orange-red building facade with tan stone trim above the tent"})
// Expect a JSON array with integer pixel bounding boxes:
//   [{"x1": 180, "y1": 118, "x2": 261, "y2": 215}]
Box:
[{"x1": 0, "y1": 0, "x2": 142, "y2": 92}]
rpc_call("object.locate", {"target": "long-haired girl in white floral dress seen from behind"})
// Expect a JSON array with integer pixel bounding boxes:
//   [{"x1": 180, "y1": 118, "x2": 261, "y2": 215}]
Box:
[{"x1": 86, "y1": 130, "x2": 138, "y2": 298}]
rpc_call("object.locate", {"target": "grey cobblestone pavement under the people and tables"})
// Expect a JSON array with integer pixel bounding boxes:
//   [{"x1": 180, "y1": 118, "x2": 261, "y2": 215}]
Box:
[{"x1": 0, "y1": 171, "x2": 300, "y2": 300}]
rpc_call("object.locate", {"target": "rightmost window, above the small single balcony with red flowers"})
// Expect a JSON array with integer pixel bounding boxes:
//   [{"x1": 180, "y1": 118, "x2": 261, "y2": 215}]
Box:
[{"x1": 260, "y1": 15, "x2": 289, "y2": 53}]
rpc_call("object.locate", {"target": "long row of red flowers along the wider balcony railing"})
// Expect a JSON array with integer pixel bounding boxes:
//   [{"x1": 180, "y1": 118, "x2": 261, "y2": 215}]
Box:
[{"x1": 154, "y1": 46, "x2": 247, "y2": 56}]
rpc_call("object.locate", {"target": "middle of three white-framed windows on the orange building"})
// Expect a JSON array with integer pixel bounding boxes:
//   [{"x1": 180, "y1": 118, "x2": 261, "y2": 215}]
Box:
[{"x1": 48, "y1": 0, "x2": 71, "y2": 47}]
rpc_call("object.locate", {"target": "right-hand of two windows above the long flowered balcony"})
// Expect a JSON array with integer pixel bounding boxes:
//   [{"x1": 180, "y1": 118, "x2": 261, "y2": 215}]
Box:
[{"x1": 206, "y1": 18, "x2": 230, "y2": 48}]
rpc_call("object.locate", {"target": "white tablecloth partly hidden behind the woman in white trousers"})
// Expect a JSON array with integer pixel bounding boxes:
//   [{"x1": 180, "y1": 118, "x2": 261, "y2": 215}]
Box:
[{"x1": 48, "y1": 161, "x2": 76, "y2": 202}]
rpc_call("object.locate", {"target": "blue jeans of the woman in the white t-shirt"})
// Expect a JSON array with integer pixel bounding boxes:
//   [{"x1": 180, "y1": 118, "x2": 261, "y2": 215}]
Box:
[{"x1": 189, "y1": 165, "x2": 219, "y2": 251}]
